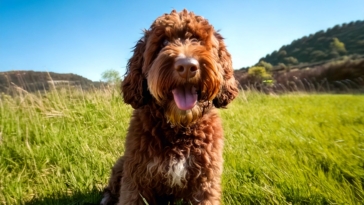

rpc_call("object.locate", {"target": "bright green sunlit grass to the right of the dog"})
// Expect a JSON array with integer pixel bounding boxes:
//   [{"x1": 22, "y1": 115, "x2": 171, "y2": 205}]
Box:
[{"x1": 221, "y1": 94, "x2": 364, "y2": 204}]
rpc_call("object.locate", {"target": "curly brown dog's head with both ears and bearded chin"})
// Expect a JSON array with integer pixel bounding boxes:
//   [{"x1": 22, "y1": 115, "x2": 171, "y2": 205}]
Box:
[{"x1": 122, "y1": 10, "x2": 238, "y2": 126}]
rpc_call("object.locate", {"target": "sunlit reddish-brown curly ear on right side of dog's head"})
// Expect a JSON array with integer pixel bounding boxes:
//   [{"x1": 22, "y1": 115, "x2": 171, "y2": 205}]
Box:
[{"x1": 212, "y1": 32, "x2": 239, "y2": 108}]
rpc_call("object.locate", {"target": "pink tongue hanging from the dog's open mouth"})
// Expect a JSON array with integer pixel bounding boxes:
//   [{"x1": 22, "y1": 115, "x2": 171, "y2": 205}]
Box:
[{"x1": 172, "y1": 86, "x2": 197, "y2": 110}]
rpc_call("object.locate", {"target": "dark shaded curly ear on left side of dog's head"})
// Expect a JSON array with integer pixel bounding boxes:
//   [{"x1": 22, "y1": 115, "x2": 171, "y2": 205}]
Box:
[{"x1": 121, "y1": 31, "x2": 151, "y2": 109}]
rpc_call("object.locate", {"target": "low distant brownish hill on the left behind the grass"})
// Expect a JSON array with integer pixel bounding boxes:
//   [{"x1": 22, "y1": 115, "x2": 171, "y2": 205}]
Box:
[{"x1": 0, "y1": 71, "x2": 100, "y2": 93}]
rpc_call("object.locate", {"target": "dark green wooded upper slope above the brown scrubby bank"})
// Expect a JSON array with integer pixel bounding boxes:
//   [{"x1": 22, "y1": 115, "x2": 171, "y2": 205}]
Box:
[{"x1": 260, "y1": 21, "x2": 364, "y2": 67}]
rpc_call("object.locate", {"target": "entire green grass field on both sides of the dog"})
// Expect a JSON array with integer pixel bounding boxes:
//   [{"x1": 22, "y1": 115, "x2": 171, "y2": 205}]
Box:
[{"x1": 0, "y1": 89, "x2": 364, "y2": 204}]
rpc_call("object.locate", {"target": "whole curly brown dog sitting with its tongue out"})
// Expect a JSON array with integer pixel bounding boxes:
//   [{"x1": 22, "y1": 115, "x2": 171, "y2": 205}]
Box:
[{"x1": 101, "y1": 10, "x2": 238, "y2": 205}]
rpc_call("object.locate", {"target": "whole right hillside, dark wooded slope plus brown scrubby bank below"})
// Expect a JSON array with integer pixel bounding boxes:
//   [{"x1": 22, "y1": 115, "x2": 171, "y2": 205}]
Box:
[{"x1": 234, "y1": 21, "x2": 364, "y2": 93}]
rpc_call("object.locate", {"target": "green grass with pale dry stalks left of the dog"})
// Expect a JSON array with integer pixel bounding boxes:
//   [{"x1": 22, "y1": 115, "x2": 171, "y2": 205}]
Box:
[{"x1": 0, "y1": 85, "x2": 131, "y2": 204}]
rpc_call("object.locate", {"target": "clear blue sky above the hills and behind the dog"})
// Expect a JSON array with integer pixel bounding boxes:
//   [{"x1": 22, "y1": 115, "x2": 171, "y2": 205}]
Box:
[{"x1": 0, "y1": 0, "x2": 364, "y2": 81}]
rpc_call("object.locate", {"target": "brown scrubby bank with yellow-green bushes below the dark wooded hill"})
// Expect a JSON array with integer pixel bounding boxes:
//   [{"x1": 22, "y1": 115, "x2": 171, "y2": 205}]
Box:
[{"x1": 235, "y1": 57, "x2": 364, "y2": 93}]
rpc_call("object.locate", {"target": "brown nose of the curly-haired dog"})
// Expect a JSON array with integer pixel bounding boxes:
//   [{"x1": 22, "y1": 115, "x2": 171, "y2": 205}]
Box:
[{"x1": 174, "y1": 58, "x2": 200, "y2": 78}]
